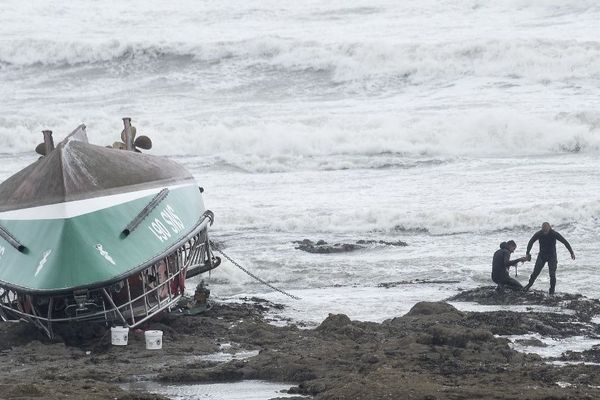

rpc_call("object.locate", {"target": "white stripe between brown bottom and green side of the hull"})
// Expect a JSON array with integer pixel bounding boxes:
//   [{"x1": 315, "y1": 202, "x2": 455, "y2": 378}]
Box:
[{"x1": 0, "y1": 183, "x2": 195, "y2": 220}]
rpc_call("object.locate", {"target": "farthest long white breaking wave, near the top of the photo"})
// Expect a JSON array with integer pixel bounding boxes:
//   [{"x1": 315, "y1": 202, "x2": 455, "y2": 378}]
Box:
[{"x1": 0, "y1": 37, "x2": 600, "y2": 84}]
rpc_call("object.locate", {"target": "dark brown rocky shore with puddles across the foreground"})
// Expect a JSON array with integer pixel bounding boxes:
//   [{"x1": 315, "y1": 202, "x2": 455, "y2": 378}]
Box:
[{"x1": 0, "y1": 287, "x2": 600, "y2": 400}]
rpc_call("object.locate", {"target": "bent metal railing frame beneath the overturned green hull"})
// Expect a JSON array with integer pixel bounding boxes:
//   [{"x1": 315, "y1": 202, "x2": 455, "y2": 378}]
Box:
[{"x1": 0, "y1": 211, "x2": 221, "y2": 338}]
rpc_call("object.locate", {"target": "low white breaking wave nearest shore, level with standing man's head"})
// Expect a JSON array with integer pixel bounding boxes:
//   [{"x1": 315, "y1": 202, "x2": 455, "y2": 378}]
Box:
[{"x1": 219, "y1": 201, "x2": 600, "y2": 237}]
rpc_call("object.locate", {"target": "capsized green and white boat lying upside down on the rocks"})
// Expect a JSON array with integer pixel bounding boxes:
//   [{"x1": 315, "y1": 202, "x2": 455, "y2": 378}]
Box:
[{"x1": 0, "y1": 118, "x2": 220, "y2": 337}]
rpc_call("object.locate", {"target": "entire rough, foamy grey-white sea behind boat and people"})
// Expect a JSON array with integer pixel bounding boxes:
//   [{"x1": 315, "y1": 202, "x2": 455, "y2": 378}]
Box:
[{"x1": 0, "y1": 0, "x2": 600, "y2": 364}]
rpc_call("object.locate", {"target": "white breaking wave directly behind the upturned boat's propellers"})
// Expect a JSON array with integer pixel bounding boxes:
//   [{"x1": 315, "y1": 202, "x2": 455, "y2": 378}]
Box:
[{"x1": 0, "y1": 110, "x2": 600, "y2": 172}]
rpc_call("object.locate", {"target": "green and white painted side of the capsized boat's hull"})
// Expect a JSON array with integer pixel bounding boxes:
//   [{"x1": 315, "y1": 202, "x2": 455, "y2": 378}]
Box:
[{"x1": 0, "y1": 184, "x2": 206, "y2": 292}]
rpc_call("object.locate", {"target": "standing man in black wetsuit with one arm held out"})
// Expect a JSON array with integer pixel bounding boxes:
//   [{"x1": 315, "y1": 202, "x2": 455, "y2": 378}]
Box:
[{"x1": 523, "y1": 222, "x2": 575, "y2": 294}]
